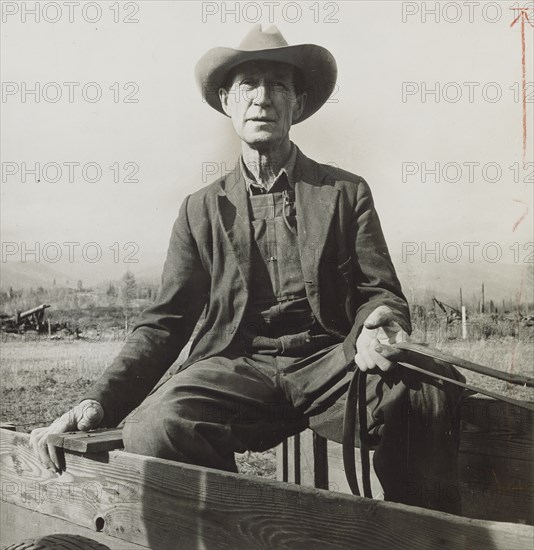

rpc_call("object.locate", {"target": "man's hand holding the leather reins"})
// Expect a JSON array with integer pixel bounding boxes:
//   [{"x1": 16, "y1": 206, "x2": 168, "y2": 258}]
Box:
[{"x1": 354, "y1": 306, "x2": 407, "y2": 372}]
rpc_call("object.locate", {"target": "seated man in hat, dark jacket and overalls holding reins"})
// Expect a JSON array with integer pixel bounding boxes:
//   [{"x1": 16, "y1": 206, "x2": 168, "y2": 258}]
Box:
[{"x1": 32, "y1": 26, "x2": 464, "y2": 510}]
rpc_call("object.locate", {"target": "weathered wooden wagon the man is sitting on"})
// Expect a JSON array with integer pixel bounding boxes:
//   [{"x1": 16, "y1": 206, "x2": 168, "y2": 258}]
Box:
[{"x1": 0, "y1": 390, "x2": 534, "y2": 550}]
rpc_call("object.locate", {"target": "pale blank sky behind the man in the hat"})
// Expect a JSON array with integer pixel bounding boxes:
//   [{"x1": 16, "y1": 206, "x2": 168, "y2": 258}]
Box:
[{"x1": 0, "y1": 0, "x2": 534, "y2": 294}]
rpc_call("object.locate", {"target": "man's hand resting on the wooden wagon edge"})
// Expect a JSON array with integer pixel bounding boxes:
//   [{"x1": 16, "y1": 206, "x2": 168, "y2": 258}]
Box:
[{"x1": 30, "y1": 399, "x2": 104, "y2": 472}]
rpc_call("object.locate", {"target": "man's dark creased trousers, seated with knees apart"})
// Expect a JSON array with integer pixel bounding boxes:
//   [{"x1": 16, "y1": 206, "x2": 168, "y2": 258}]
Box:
[{"x1": 123, "y1": 344, "x2": 461, "y2": 513}]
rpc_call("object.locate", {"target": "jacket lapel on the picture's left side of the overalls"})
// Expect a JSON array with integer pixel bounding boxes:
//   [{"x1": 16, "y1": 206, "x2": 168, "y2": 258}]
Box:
[{"x1": 217, "y1": 162, "x2": 252, "y2": 289}]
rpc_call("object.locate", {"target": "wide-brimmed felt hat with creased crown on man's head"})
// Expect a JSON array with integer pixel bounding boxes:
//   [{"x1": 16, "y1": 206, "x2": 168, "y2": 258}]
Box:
[{"x1": 195, "y1": 24, "x2": 337, "y2": 124}]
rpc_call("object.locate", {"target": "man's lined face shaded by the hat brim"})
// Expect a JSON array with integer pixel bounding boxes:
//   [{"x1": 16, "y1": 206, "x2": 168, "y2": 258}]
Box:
[{"x1": 219, "y1": 61, "x2": 306, "y2": 149}]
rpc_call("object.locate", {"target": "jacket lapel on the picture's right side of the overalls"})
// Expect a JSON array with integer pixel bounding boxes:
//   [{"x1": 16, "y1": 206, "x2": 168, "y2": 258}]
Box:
[{"x1": 295, "y1": 150, "x2": 339, "y2": 286}]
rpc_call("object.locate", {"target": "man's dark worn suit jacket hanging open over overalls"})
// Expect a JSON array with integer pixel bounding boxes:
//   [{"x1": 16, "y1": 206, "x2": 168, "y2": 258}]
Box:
[{"x1": 85, "y1": 150, "x2": 410, "y2": 426}]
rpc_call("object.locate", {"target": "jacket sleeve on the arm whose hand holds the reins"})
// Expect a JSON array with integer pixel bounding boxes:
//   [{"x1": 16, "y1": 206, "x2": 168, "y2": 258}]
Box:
[{"x1": 344, "y1": 179, "x2": 412, "y2": 359}]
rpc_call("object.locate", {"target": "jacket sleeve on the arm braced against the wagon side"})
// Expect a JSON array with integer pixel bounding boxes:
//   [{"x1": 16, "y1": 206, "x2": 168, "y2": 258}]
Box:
[{"x1": 83, "y1": 197, "x2": 209, "y2": 427}]
